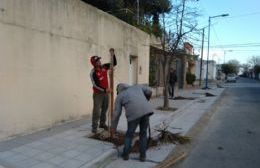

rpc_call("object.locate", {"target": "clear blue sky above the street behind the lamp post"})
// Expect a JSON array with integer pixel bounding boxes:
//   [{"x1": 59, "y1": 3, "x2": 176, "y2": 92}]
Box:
[{"x1": 190, "y1": 0, "x2": 260, "y2": 64}]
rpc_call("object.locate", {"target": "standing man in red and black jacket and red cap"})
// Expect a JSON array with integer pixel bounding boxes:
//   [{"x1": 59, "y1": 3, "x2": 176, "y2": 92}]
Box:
[{"x1": 90, "y1": 48, "x2": 117, "y2": 133}]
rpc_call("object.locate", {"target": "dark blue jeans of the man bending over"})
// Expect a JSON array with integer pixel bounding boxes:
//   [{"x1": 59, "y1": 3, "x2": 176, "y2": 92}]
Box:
[{"x1": 123, "y1": 115, "x2": 149, "y2": 157}]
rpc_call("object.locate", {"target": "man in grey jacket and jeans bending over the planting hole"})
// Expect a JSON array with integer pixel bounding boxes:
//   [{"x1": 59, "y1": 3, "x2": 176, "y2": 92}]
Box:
[{"x1": 110, "y1": 83, "x2": 153, "y2": 161}]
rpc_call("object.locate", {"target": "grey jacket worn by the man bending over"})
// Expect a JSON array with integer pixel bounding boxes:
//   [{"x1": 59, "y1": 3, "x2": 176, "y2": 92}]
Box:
[{"x1": 111, "y1": 84, "x2": 153, "y2": 129}]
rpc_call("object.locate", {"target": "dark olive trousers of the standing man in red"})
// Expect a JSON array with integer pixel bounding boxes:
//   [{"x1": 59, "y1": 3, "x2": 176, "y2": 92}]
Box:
[{"x1": 92, "y1": 93, "x2": 109, "y2": 129}]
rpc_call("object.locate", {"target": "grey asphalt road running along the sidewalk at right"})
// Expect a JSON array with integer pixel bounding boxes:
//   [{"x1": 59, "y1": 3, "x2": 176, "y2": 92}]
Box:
[{"x1": 175, "y1": 78, "x2": 260, "y2": 168}]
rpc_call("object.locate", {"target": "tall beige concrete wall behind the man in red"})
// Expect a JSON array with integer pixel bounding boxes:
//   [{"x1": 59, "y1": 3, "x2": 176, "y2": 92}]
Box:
[{"x1": 0, "y1": 0, "x2": 150, "y2": 140}]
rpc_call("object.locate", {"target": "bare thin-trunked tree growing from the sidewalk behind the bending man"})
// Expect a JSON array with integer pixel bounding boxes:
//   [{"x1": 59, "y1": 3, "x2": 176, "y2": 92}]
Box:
[{"x1": 158, "y1": 0, "x2": 198, "y2": 110}]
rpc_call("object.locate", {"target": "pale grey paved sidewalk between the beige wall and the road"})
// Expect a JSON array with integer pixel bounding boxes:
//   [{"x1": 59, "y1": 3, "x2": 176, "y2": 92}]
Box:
[{"x1": 0, "y1": 88, "x2": 224, "y2": 168}]
